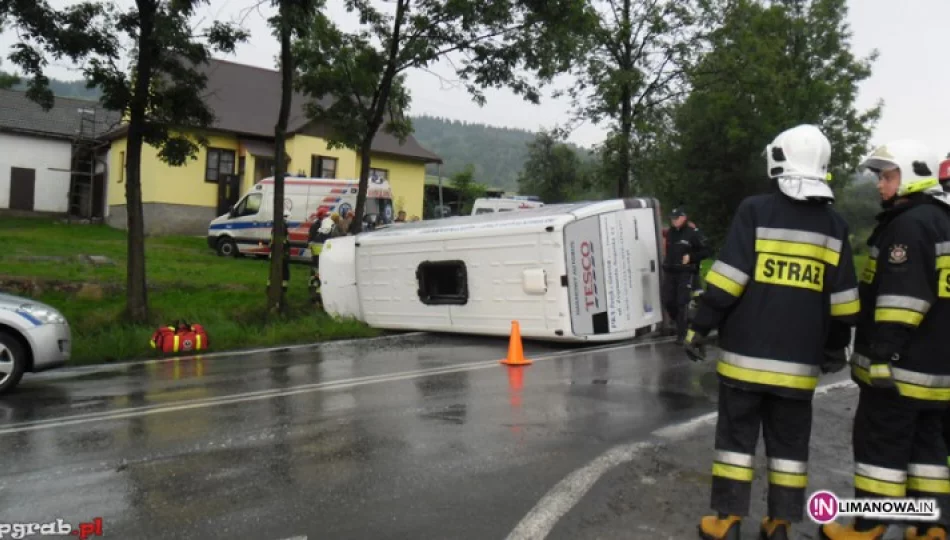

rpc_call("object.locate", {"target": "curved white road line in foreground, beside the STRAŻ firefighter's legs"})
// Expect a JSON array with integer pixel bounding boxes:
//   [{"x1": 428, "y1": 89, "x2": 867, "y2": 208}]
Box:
[{"x1": 507, "y1": 380, "x2": 855, "y2": 540}]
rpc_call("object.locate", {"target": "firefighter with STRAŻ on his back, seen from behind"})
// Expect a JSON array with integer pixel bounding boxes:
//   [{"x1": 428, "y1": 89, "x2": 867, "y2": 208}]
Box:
[{"x1": 684, "y1": 125, "x2": 859, "y2": 540}]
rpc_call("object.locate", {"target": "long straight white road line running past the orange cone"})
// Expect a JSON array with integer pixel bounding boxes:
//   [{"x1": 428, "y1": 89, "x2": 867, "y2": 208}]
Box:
[{"x1": 0, "y1": 339, "x2": 669, "y2": 435}]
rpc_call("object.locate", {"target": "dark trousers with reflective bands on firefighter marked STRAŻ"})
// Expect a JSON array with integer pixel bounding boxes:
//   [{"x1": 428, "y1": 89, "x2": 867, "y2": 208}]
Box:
[{"x1": 711, "y1": 381, "x2": 812, "y2": 522}]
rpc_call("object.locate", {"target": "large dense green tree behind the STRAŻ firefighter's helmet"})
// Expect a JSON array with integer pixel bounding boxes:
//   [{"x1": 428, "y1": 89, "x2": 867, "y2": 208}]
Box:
[{"x1": 657, "y1": 0, "x2": 881, "y2": 245}]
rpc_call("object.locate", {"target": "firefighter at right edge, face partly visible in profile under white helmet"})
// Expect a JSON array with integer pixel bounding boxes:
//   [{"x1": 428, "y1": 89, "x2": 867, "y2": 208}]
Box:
[{"x1": 820, "y1": 140, "x2": 950, "y2": 540}]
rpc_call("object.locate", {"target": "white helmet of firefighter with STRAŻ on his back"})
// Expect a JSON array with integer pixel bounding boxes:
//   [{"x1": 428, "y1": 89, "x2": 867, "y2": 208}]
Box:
[{"x1": 765, "y1": 124, "x2": 835, "y2": 201}]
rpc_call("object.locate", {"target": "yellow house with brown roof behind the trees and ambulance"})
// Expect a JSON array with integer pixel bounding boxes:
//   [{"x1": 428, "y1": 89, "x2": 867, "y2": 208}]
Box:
[{"x1": 106, "y1": 60, "x2": 442, "y2": 234}]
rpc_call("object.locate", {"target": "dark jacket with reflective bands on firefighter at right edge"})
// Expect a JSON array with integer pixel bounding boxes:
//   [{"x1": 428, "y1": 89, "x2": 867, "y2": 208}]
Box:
[{"x1": 851, "y1": 194, "x2": 950, "y2": 406}]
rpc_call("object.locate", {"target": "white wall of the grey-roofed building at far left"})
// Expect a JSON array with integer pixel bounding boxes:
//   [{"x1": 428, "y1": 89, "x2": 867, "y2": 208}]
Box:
[{"x1": 0, "y1": 133, "x2": 72, "y2": 213}]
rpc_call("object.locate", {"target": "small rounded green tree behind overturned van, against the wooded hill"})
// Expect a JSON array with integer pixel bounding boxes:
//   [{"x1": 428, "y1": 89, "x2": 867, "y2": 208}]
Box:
[{"x1": 518, "y1": 131, "x2": 594, "y2": 203}]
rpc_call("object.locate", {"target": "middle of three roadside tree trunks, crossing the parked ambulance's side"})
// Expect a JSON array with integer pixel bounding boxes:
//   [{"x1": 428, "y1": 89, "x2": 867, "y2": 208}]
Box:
[{"x1": 267, "y1": 0, "x2": 294, "y2": 313}]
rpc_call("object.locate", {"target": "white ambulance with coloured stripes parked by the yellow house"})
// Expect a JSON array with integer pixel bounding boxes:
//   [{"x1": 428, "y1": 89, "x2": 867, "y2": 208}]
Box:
[{"x1": 208, "y1": 176, "x2": 393, "y2": 260}]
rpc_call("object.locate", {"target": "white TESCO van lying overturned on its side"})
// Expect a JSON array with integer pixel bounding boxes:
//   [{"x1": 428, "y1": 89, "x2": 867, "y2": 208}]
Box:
[{"x1": 320, "y1": 198, "x2": 663, "y2": 342}]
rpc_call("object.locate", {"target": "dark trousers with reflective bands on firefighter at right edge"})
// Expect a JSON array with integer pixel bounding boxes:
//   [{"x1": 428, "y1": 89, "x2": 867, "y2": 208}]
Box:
[{"x1": 852, "y1": 385, "x2": 950, "y2": 527}]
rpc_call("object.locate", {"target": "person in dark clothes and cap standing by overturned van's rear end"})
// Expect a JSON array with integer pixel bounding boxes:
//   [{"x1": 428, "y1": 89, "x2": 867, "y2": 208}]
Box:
[{"x1": 663, "y1": 208, "x2": 710, "y2": 343}]
